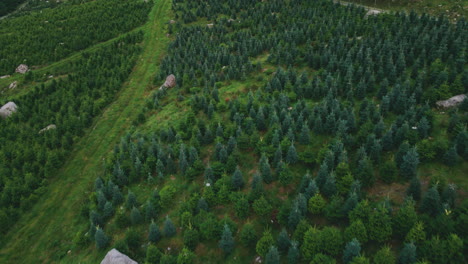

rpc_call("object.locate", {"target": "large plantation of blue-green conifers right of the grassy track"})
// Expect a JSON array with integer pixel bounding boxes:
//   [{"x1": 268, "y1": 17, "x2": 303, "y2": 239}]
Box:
[{"x1": 79, "y1": 0, "x2": 468, "y2": 263}]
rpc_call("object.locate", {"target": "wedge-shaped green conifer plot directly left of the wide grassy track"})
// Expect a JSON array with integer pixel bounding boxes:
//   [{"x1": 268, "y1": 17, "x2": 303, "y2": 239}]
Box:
[{"x1": 0, "y1": 31, "x2": 143, "y2": 239}]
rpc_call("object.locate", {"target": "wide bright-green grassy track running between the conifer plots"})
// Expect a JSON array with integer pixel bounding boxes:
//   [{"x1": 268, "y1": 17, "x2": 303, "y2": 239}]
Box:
[{"x1": 0, "y1": 0, "x2": 170, "y2": 263}]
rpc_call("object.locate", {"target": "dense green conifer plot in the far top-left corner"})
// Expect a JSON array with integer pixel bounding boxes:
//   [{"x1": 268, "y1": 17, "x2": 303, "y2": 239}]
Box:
[{"x1": 0, "y1": 0, "x2": 152, "y2": 75}]
